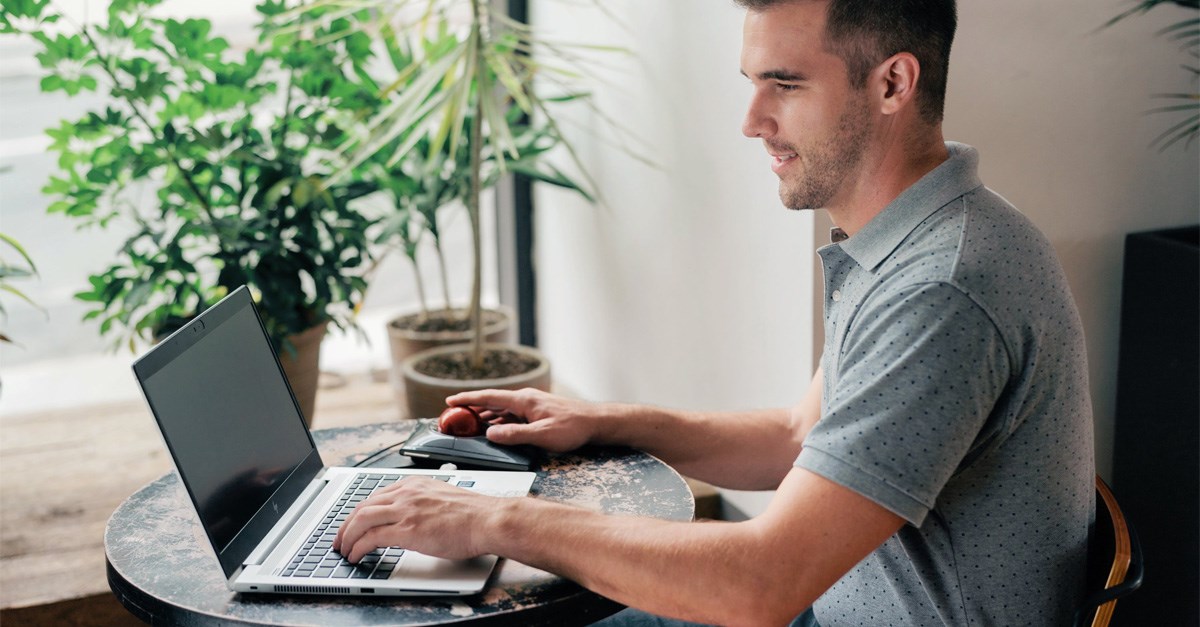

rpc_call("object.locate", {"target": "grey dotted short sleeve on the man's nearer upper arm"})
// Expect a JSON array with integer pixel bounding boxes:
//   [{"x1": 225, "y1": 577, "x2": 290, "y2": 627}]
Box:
[{"x1": 796, "y1": 282, "x2": 1010, "y2": 525}]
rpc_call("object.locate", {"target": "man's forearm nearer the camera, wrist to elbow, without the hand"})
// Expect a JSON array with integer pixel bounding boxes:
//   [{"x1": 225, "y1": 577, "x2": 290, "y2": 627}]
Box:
[{"x1": 484, "y1": 490, "x2": 803, "y2": 625}]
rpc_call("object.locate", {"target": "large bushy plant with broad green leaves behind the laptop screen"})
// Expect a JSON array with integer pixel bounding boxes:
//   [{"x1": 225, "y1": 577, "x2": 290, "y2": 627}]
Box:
[{"x1": 0, "y1": 0, "x2": 410, "y2": 419}]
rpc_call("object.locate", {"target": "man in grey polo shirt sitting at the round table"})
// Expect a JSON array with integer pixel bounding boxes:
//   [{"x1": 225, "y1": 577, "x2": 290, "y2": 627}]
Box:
[{"x1": 337, "y1": 0, "x2": 1094, "y2": 627}]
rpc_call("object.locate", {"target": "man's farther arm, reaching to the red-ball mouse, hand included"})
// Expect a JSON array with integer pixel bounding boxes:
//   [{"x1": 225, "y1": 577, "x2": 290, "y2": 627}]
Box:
[{"x1": 448, "y1": 369, "x2": 822, "y2": 490}]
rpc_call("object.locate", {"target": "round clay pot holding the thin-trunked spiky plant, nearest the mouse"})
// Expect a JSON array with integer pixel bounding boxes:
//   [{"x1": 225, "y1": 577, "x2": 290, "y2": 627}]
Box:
[{"x1": 401, "y1": 344, "x2": 550, "y2": 418}]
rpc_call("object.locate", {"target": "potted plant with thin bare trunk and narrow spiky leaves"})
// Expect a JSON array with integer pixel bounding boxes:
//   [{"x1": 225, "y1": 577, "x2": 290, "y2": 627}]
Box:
[{"x1": 288, "y1": 0, "x2": 609, "y2": 417}]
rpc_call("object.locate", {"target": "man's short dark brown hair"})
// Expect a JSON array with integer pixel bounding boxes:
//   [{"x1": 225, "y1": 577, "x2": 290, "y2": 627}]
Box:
[{"x1": 733, "y1": 0, "x2": 958, "y2": 124}]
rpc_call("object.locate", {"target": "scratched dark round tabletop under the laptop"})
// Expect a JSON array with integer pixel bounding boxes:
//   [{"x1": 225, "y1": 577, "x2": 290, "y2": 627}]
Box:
[{"x1": 104, "y1": 420, "x2": 695, "y2": 627}]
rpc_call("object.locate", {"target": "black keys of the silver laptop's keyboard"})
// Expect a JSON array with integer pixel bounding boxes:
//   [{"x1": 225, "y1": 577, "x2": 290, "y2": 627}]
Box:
[{"x1": 281, "y1": 474, "x2": 450, "y2": 579}]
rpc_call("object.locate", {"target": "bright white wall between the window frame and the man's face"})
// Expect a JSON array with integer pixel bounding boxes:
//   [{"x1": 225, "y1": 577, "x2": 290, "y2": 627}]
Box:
[{"x1": 535, "y1": 0, "x2": 812, "y2": 410}]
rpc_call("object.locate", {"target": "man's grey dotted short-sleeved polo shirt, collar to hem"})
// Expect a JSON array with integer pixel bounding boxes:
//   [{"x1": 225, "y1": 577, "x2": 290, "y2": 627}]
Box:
[{"x1": 796, "y1": 143, "x2": 1094, "y2": 627}]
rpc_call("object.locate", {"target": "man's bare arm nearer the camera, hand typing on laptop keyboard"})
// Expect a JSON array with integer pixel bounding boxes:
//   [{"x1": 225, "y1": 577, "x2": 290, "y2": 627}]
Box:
[{"x1": 335, "y1": 458, "x2": 904, "y2": 626}]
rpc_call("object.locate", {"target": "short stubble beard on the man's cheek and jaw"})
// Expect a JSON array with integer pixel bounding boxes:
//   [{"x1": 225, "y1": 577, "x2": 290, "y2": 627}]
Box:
[{"x1": 779, "y1": 96, "x2": 870, "y2": 210}]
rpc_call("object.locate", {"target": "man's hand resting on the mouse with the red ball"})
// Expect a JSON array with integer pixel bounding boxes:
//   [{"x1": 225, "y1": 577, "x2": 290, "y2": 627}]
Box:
[{"x1": 446, "y1": 388, "x2": 601, "y2": 453}]
